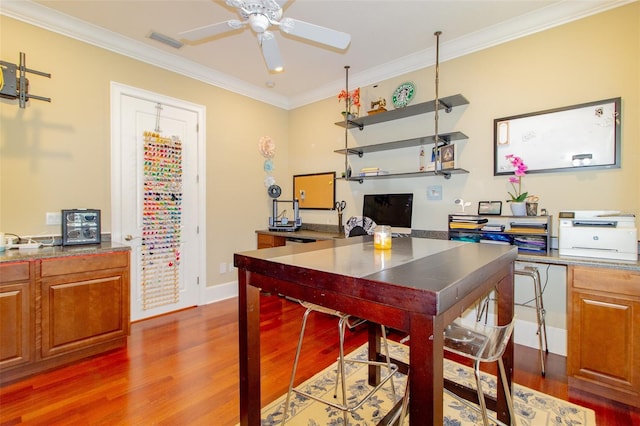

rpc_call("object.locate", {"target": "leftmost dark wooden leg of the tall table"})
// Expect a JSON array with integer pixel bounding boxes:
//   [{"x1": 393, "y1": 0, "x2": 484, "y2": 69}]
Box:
[{"x1": 238, "y1": 269, "x2": 261, "y2": 426}]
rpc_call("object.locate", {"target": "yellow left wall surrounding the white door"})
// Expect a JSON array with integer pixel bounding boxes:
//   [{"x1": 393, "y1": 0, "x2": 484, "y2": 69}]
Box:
[{"x1": 0, "y1": 16, "x2": 290, "y2": 285}]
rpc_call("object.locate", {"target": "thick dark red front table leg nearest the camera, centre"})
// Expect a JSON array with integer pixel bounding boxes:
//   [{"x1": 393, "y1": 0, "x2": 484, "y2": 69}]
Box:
[{"x1": 409, "y1": 314, "x2": 444, "y2": 426}]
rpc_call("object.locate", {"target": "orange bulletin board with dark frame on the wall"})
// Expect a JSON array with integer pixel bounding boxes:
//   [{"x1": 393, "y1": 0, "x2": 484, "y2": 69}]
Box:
[{"x1": 293, "y1": 172, "x2": 336, "y2": 210}]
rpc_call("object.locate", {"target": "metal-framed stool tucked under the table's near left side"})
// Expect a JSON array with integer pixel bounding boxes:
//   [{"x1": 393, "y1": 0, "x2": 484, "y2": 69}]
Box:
[{"x1": 282, "y1": 301, "x2": 398, "y2": 426}]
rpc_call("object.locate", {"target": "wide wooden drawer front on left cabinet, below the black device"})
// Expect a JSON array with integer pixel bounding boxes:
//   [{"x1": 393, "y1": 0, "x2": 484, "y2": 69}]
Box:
[{"x1": 40, "y1": 252, "x2": 129, "y2": 277}]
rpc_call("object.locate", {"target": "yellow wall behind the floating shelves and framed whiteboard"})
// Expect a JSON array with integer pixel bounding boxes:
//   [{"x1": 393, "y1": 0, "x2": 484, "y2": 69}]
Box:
[{"x1": 289, "y1": 3, "x2": 640, "y2": 235}]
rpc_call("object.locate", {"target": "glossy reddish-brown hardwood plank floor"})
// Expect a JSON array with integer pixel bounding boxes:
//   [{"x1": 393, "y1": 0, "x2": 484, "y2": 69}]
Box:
[{"x1": 0, "y1": 296, "x2": 640, "y2": 426}]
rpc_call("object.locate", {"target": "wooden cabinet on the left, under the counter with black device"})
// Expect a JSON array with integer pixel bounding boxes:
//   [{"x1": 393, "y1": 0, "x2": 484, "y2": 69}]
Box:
[{"x1": 0, "y1": 251, "x2": 129, "y2": 384}]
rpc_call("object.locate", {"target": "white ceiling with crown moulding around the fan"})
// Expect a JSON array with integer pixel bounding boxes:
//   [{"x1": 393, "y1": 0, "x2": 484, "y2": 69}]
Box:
[{"x1": 0, "y1": 0, "x2": 634, "y2": 109}]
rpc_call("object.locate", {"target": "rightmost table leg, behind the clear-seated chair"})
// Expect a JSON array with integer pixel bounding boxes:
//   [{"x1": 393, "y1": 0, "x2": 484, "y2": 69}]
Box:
[{"x1": 496, "y1": 263, "x2": 514, "y2": 424}]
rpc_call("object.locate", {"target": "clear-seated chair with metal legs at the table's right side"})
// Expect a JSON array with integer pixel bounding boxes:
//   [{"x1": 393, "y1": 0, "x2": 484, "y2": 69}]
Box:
[{"x1": 392, "y1": 319, "x2": 516, "y2": 426}]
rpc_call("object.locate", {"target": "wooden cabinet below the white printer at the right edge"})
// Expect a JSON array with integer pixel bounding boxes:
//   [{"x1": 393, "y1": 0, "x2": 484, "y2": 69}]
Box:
[{"x1": 567, "y1": 266, "x2": 640, "y2": 407}]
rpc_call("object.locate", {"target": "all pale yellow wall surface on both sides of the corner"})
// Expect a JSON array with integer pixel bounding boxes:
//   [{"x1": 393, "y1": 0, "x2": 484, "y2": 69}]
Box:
[{"x1": 0, "y1": 2, "x2": 640, "y2": 285}]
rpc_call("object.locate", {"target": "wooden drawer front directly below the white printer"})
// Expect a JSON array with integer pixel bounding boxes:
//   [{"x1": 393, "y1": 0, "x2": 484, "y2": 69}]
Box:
[{"x1": 573, "y1": 267, "x2": 640, "y2": 296}]
